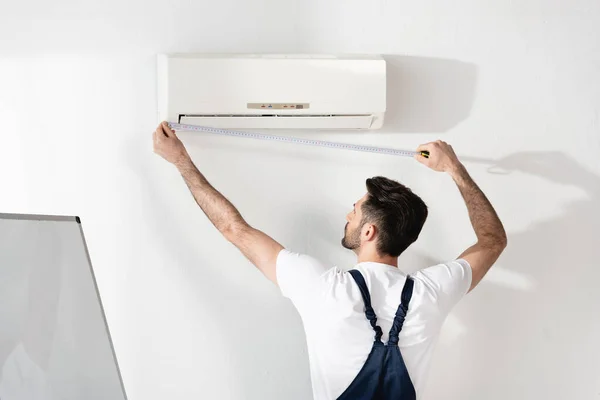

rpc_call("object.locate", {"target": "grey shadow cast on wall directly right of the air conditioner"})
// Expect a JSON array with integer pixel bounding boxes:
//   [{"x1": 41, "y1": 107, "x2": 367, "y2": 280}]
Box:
[{"x1": 378, "y1": 55, "x2": 477, "y2": 133}]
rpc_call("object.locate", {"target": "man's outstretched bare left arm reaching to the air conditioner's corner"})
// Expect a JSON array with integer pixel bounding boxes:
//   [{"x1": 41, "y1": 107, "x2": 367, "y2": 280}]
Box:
[{"x1": 153, "y1": 122, "x2": 283, "y2": 284}]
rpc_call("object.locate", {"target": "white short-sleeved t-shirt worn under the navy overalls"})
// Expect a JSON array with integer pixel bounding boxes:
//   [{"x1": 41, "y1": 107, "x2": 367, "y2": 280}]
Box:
[{"x1": 276, "y1": 249, "x2": 471, "y2": 400}]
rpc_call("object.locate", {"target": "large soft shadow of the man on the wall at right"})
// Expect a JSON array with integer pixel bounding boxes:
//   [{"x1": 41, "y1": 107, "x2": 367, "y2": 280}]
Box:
[{"x1": 427, "y1": 152, "x2": 600, "y2": 400}]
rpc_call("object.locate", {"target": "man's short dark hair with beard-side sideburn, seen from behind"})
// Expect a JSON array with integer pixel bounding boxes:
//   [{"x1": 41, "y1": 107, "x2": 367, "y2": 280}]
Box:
[{"x1": 361, "y1": 176, "x2": 427, "y2": 257}]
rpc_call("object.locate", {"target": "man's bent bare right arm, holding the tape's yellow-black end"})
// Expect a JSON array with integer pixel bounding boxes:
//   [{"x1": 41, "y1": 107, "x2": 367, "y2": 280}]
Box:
[{"x1": 415, "y1": 140, "x2": 507, "y2": 291}]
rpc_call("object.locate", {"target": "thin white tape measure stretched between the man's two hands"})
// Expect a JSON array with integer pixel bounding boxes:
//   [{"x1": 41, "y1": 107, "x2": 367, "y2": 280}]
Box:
[{"x1": 167, "y1": 122, "x2": 429, "y2": 158}]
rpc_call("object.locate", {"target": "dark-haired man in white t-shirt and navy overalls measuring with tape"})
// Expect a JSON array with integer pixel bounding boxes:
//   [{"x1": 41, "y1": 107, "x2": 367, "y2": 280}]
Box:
[{"x1": 154, "y1": 122, "x2": 507, "y2": 400}]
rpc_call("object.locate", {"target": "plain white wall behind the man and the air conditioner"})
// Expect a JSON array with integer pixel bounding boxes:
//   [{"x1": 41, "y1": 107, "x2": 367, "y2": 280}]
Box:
[{"x1": 0, "y1": 0, "x2": 600, "y2": 400}]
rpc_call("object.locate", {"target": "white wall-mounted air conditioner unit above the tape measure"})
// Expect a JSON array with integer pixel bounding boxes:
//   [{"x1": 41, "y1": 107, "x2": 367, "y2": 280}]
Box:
[{"x1": 157, "y1": 54, "x2": 386, "y2": 129}]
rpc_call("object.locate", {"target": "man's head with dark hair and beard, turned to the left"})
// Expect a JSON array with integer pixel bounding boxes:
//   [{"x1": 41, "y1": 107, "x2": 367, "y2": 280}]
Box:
[{"x1": 342, "y1": 176, "x2": 427, "y2": 257}]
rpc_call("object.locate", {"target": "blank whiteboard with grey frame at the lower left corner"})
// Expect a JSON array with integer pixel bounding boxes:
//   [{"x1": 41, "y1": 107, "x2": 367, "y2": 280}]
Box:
[{"x1": 0, "y1": 214, "x2": 127, "y2": 400}]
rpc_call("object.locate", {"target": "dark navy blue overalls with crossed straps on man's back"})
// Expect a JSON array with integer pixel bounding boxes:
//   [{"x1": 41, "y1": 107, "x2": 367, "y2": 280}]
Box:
[{"x1": 338, "y1": 269, "x2": 416, "y2": 400}]
